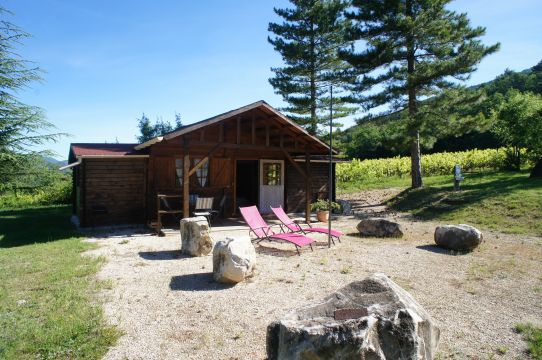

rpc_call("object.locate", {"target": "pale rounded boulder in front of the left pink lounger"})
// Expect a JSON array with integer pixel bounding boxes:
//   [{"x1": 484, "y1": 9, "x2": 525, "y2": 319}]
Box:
[{"x1": 213, "y1": 236, "x2": 256, "y2": 284}]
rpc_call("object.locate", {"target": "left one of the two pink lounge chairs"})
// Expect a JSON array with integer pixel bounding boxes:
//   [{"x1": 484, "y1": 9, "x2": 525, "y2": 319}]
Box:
[{"x1": 239, "y1": 206, "x2": 314, "y2": 255}]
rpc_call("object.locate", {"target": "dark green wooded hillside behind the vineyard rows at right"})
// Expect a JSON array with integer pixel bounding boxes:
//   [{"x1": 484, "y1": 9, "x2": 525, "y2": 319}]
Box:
[{"x1": 337, "y1": 61, "x2": 542, "y2": 158}]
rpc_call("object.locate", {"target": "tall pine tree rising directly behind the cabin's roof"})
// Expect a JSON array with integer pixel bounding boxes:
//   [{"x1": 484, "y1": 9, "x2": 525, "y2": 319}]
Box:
[{"x1": 268, "y1": 0, "x2": 355, "y2": 135}]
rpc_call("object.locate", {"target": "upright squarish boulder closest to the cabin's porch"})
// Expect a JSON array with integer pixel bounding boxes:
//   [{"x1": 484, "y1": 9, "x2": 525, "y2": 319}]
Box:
[{"x1": 181, "y1": 216, "x2": 213, "y2": 256}]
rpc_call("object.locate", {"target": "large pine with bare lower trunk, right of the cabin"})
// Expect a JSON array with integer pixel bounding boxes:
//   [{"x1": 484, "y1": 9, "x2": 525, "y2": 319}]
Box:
[{"x1": 341, "y1": 0, "x2": 499, "y2": 188}]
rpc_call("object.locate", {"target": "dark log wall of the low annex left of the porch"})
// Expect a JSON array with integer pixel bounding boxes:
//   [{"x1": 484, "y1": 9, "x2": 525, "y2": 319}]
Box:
[{"x1": 79, "y1": 157, "x2": 147, "y2": 226}]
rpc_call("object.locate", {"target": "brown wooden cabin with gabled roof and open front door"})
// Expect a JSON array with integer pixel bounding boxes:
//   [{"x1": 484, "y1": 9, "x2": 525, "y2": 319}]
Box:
[{"x1": 67, "y1": 101, "x2": 342, "y2": 226}]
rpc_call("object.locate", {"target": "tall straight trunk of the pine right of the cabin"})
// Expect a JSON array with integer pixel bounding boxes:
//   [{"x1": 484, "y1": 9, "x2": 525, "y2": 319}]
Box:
[{"x1": 405, "y1": 0, "x2": 423, "y2": 188}]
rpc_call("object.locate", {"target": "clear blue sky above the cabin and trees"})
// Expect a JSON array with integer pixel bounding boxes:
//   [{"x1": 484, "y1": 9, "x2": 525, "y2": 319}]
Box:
[{"x1": 7, "y1": 0, "x2": 542, "y2": 158}]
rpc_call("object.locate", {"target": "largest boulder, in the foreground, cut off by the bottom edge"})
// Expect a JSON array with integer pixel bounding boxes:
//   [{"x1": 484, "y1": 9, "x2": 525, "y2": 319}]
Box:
[{"x1": 267, "y1": 274, "x2": 440, "y2": 360}]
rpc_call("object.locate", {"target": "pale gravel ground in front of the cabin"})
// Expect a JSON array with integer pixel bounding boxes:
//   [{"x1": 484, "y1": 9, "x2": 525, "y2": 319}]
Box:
[{"x1": 88, "y1": 194, "x2": 542, "y2": 359}]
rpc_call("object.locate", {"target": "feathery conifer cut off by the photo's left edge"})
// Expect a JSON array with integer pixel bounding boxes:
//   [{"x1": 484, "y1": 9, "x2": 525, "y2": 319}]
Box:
[{"x1": 0, "y1": 7, "x2": 64, "y2": 185}]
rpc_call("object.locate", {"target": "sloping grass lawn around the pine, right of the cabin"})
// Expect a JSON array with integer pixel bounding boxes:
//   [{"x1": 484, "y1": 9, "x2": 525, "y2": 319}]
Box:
[{"x1": 339, "y1": 172, "x2": 542, "y2": 236}]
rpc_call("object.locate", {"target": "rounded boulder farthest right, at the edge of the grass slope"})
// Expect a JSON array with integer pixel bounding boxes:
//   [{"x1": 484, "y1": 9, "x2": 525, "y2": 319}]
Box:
[{"x1": 435, "y1": 224, "x2": 483, "y2": 251}]
